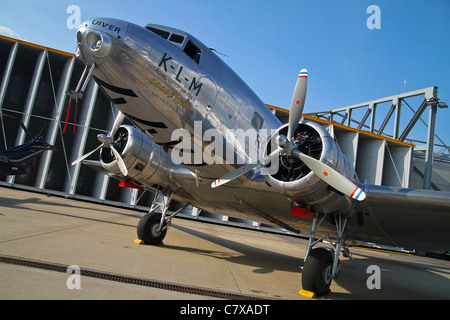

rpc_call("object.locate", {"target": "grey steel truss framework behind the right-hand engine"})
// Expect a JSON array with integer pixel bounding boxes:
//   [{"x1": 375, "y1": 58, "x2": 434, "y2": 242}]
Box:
[{"x1": 309, "y1": 86, "x2": 450, "y2": 189}]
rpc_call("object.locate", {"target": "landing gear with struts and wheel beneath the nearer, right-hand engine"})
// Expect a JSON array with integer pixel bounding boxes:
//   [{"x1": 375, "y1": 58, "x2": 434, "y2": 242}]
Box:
[{"x1": 302, "y1": 213, "x2": 356, "y2": 296}]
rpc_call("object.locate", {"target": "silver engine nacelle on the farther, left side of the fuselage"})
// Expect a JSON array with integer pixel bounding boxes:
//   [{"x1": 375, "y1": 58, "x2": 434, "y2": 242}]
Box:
[{"x1": 100, "y1": 125, "x2": 174, "y2": 187}]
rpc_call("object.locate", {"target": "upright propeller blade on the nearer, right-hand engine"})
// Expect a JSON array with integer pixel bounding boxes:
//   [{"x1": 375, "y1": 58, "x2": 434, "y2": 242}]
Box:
[{"x1": 287, "y1": 69, "x2": 308, "y2": 139}]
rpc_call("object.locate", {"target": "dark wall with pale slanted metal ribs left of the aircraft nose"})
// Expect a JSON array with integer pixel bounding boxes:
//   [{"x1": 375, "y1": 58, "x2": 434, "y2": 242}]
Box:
[{"x1": 0, "y1": 39, "x2": 118, "y2": 200}]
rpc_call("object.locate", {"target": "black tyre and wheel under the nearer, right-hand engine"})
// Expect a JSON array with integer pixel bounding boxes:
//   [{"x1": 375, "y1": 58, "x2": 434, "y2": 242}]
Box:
[{"x1": 302, "y1": 248, "x2": 333, "y2": 296}]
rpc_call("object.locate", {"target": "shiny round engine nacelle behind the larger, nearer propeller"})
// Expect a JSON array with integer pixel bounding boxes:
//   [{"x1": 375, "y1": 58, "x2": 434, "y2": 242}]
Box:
[{"x1": 265, "y1": 120, "x2": 357, "y2": 216}]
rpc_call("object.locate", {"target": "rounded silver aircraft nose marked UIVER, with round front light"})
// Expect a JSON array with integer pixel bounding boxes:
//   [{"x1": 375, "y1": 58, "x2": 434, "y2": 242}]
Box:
[{"x1": 76, "y1": 18, "x2": 128, "y2": 58}]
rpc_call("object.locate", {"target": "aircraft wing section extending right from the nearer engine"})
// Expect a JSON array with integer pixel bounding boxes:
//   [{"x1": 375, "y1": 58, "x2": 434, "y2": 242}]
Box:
[{"x1": 358, "y1": 185, "x2": 450, "y2": 251}]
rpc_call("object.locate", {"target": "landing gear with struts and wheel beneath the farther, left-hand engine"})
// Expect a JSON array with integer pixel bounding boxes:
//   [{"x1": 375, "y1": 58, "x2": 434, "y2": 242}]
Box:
[{"x1": 137, "y1": 188, "x2": 190, "y2": 245}]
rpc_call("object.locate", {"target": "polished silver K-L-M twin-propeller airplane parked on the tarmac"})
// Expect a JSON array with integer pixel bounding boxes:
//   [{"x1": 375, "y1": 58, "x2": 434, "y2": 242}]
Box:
[{"x1": 68, "y1": 18, "x2": 450, "y2": 295}]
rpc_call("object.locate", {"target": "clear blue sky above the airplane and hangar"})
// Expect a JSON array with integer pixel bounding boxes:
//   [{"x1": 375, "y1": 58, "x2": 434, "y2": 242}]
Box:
[{"x1": 0, "y1": 0, "x2": 450, "y2": 144}]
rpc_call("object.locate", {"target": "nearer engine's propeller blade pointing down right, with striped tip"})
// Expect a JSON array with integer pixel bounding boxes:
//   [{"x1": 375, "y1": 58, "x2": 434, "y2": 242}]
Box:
[{"x1": 292, "y1": 149, "x2": 366, "y2": 201}]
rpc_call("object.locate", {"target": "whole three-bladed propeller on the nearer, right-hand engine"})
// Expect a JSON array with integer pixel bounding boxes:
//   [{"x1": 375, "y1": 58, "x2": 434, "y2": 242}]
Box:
[{"x1": 211, "y1": 69, "x2": 366, "y2": 201}]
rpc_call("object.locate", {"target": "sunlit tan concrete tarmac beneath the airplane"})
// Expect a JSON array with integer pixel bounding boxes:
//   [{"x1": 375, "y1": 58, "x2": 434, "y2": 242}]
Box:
[{"x1": 0, "y1": 187, "x2": 450, "y2": 300}]
